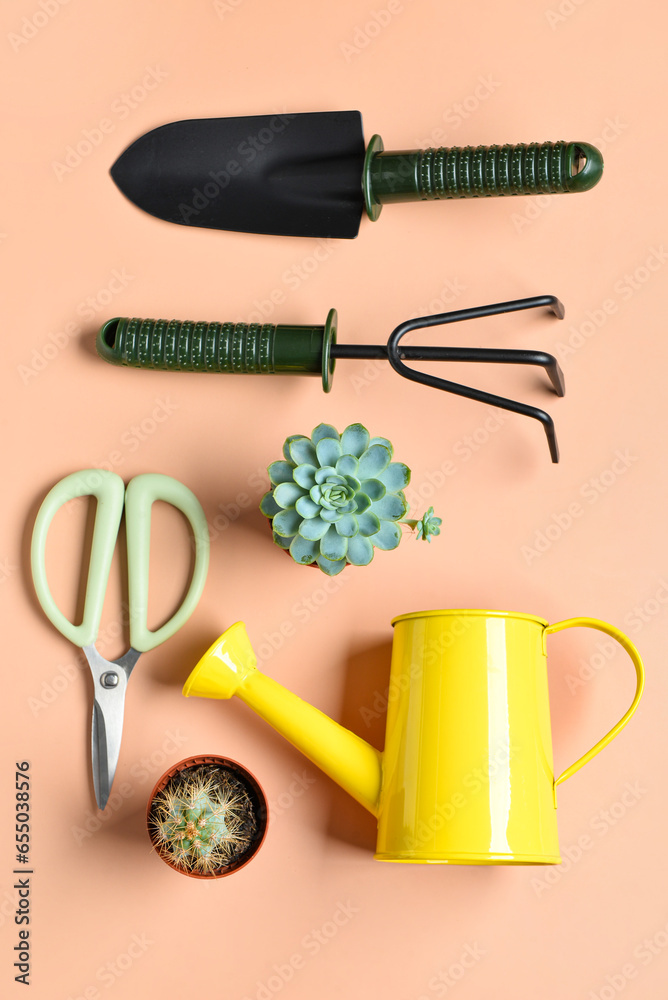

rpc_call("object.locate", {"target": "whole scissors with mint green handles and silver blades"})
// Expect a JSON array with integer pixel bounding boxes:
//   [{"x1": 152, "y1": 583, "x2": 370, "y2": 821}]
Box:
[{"x1": 31, "y1": 469, "x2": 209, "y2": 809}]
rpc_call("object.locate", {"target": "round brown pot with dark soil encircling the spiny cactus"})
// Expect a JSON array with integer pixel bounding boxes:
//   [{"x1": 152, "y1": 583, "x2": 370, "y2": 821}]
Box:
[{"x1": 146, "y1": 754, "x2": 268, "y2": 879}]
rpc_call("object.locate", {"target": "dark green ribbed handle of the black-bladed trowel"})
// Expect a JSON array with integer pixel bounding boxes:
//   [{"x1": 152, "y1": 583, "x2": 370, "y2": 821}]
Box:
[{"x1": 363, "y1": 135, "x2": 603, "y2": 221}]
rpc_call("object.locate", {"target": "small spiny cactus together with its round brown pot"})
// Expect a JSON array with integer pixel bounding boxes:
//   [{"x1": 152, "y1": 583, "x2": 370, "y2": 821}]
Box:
[{"x1": 147, "y1": 757, "x2": 266, "y2": 878}]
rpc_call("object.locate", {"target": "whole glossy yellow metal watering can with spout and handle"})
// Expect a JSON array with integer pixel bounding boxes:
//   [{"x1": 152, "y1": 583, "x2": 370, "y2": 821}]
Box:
[{"x1": 183, "y1": 611, "x2": 644, "y2": 865}]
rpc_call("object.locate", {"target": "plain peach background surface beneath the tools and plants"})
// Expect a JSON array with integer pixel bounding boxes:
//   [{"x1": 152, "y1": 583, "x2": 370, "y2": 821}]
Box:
[{"x1": 0, "y1": 0, "x2": 668, "y2": 1000}]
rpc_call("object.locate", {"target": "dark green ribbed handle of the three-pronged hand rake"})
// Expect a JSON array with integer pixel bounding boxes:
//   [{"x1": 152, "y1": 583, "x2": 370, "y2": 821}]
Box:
[{"x1": 97, "y1": 309, "x2": 336, "y2": 392}]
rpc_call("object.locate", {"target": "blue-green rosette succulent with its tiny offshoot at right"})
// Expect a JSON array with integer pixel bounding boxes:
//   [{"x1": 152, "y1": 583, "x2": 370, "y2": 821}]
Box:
[{"x1": 260, "y1": 424, "x2": 440, "y2": 576}]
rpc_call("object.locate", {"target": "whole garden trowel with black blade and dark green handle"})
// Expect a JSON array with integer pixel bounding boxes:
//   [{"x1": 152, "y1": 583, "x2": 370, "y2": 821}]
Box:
[{"x1": 111, "y1": 111, "x2": 603, "y2": 239}]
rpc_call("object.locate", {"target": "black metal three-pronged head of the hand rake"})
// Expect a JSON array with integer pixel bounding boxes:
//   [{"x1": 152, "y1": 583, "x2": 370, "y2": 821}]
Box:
[{"x1": 387, "y1": 295, "x2": 564, "y2": 462}]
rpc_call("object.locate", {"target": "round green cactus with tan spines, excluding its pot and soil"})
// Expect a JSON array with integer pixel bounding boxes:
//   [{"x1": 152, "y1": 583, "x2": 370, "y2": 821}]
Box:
[{"x1": 149, "y1": 768, "x2": 258, "y2": 875}]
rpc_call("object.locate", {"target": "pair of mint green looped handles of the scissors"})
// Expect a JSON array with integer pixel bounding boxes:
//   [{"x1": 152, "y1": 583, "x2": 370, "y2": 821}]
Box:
[{"x1": 31, "y1": 469, "x2": 209, "y2": 653}]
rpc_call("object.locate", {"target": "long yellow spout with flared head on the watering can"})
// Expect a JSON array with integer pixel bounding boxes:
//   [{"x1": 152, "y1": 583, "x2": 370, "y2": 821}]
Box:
[{"x1": 183, "y1": 622, "x2": 382, "y2": 817}]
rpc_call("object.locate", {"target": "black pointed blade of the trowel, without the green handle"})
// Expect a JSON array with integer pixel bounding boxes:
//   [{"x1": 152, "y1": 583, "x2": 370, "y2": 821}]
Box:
[{"x1": 111, "y1": 111, "x2": 364, "y2": 239}]
